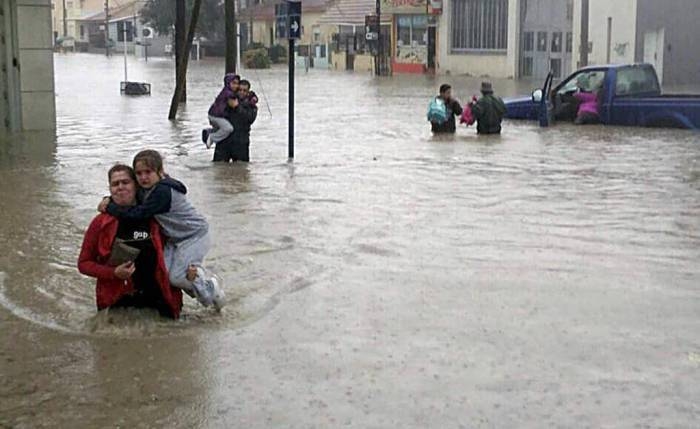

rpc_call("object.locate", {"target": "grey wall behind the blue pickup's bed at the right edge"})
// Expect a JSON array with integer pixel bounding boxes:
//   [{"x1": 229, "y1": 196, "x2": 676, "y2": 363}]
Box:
[{"x1": 635, "y1": 0, "x2": 700, "y2": 85}]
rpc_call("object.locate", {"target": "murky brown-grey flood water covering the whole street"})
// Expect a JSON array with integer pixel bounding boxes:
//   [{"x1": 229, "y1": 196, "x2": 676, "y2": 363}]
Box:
[{"x1": 0, "y1": 54, "x2": 700, "y2": 428}]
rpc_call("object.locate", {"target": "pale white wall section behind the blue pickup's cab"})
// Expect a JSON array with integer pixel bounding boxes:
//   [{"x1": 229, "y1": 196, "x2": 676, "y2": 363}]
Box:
[{"x1": 573, "y1": 0, "x2": 637, "y2": 65}]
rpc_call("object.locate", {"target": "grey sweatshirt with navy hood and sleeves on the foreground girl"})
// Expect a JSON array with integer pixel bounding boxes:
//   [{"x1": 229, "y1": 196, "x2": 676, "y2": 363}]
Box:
[{"x1": 107, "y1": 176, "x2": 209, "y2": 243}]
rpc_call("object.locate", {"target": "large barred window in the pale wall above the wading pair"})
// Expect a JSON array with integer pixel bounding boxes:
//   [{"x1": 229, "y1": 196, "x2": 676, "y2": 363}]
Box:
[{"x1": 452, "y1": 0, "x2": 508, "y2": 52}]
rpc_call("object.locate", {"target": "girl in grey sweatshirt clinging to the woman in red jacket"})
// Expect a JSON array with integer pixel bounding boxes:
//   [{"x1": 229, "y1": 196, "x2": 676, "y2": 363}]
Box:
[{"x1": 101, "y1": 150, "x2": 225, "y2": 310}]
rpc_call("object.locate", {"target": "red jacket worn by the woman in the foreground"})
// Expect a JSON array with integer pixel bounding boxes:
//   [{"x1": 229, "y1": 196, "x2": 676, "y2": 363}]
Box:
[{"x1": 78, "y1": 213, "x2": 182, "y2": 319}]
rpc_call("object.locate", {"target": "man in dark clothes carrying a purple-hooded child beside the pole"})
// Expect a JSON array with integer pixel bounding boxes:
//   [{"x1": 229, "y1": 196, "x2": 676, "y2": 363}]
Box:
[{"x1": 213, "y1": 80, "x2": 258, "y2": 162}]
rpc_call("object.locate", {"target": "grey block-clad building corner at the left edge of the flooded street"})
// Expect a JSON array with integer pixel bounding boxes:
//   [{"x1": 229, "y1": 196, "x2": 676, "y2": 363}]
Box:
[{"x1": 0, "y1": 0, "x2": 56, "y2": 138}]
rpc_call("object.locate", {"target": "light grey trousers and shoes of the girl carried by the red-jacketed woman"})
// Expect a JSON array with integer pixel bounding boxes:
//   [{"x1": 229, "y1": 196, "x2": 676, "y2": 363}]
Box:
[{"x1": 166, "y1": 233, "x2": 225, "y2": 310}]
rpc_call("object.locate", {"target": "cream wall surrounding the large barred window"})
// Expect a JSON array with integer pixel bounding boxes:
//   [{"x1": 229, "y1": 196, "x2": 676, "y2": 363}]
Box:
[{"x1": 437, "y1": 0, "x2": 520, "y2": 78}]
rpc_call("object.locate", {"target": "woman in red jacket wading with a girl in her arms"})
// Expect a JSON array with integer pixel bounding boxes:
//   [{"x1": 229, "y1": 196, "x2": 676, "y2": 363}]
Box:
[{"x1": 78, "y1": 164, "x2": 182, "y2": 319}]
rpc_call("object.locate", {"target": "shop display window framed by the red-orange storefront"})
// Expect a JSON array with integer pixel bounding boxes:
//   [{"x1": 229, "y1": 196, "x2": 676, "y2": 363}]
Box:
[{"x1": 396, "y1": 15, "x2": 428, "y2": 64}]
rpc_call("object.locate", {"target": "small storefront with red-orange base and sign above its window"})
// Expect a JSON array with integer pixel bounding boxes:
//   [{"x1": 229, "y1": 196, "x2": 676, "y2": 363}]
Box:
[{"x1": 382, "y1": 0, "x2": 442, "y2": 73}]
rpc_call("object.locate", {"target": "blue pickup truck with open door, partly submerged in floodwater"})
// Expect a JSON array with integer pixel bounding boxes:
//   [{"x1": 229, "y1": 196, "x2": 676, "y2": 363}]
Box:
[{"x1": 505, "y1": 64, "x2": 700, "y2": 130}]
